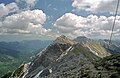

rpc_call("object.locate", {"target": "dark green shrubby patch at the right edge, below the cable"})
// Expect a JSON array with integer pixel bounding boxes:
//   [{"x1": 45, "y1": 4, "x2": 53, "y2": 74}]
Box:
[{"x1": 96, "y1": 54, "x2": 120, "y2": 72}]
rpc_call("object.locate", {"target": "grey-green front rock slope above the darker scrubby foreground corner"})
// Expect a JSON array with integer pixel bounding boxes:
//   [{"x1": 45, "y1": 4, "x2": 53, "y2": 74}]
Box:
[{"x1": 46, "y1": 44, "x2": 100, "y2": 78}]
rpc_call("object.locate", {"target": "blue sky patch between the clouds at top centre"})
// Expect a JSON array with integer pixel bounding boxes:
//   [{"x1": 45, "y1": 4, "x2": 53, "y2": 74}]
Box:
[{"x1": 35, "y1": 0, "x2": 72, "y2": 27}]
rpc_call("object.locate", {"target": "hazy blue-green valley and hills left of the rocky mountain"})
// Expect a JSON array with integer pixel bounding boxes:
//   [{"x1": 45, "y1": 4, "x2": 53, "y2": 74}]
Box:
[{"x1": 0, "y1": 40, "x2": 52, "y2": 77}]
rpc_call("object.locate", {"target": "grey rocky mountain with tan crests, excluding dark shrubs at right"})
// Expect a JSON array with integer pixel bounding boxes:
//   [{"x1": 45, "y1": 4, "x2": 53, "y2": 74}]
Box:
[{"x1": 7, "y1": 35, "x2": 110, "y2": 78}]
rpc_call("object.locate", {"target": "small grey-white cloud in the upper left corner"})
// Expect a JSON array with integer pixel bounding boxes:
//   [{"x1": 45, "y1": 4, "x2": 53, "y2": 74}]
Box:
[{"x1": 0, "y1": 2, "x2": 19, "y2": 17}]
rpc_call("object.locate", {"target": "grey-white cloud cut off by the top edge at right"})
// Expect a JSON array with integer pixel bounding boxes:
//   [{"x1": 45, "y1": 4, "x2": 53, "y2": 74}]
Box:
[{"x1": 72, "y1": 0, "x2": 120, "y2": 13}]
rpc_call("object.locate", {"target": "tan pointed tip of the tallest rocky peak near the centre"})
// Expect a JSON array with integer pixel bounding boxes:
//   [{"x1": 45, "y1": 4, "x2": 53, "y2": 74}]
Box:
[{"x1": 54, "y1": 35, "x2": 75, "y2": 45}]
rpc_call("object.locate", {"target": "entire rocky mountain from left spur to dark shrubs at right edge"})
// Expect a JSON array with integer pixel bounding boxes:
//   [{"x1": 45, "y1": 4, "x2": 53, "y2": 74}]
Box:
[{"x1": 3, "y1": 35, "x2": 120, "y2": 78}]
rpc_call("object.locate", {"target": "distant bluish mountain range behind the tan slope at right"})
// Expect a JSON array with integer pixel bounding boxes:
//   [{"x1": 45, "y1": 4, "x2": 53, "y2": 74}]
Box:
[{"x1": 74, "y1": 36, "x2": 120, "y2": 53}]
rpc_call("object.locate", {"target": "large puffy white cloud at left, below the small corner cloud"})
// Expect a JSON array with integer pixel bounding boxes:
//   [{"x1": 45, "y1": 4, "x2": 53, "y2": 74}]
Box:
[{"x1": 0, "y1": 10, "x2": 51, "y2": 35}]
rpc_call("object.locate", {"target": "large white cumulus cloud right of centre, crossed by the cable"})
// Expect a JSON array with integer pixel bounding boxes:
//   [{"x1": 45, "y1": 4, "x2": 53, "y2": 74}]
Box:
[{"x1": 54, "y1": 13, "x2": 120, "y2": 37}]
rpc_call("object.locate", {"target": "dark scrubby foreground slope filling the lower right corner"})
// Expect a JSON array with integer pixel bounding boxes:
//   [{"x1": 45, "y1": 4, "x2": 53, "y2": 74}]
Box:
[{"x1": 50, "y1": 54, "x2": 120, "y2": 78}]
